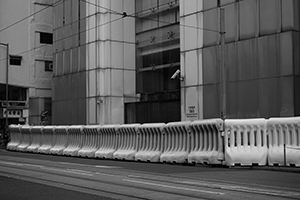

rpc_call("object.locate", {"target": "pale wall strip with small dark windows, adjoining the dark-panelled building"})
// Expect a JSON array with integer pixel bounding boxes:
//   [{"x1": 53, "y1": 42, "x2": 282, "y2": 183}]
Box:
[{"x1": 29, "y1": 0, "x2": 53, "y2": 124}]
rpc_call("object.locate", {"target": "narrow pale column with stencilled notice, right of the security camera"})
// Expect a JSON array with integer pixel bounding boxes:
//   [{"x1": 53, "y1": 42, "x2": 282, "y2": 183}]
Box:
[{"x1": 180, "y1": 0, "x2": 203, "y2": 121}]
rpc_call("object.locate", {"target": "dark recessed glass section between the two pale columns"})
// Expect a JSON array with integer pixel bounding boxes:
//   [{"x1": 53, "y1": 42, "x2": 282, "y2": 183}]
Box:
[{"x1": 125, "y1": 0, "x2": 181, "y2": 123}]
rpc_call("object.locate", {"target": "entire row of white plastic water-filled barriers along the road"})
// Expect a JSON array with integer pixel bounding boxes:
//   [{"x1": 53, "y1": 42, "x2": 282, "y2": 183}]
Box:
[{"x1": 7, "y1": 117, "x2": 300, "y2": 167}]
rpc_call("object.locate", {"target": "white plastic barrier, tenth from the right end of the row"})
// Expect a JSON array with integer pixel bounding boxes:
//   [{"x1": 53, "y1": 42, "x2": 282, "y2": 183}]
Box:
[{"x1": 49, "y1": 126, "x2": 68, "y2": 155}]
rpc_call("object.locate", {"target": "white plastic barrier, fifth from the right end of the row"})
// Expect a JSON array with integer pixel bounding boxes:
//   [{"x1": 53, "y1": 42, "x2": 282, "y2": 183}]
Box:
[{"x1": 135, "y1": 123, "x2": 165, "y2": 162}]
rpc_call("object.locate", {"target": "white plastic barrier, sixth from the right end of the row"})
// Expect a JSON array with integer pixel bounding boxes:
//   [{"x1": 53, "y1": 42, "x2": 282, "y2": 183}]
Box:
[{"x1": 113, "y1": 124, "x2": 141, "y2": 160}]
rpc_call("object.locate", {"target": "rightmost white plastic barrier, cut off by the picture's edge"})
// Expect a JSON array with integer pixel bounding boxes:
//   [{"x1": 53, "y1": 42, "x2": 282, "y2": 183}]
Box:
[{"x1": 268, "y1": 117, "x2": 300, "y2": 167}]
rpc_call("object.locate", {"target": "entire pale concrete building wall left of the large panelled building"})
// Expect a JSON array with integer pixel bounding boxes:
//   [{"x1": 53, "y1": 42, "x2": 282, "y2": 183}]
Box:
[{"x1": 0, "y1": 0, "x2": 52, "y2": 124}]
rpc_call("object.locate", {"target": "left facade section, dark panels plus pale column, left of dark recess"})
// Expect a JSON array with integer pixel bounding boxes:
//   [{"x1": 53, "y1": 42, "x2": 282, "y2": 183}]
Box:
[{"x1": 52, "y1": 0, "x2": 137, "y2": 124}]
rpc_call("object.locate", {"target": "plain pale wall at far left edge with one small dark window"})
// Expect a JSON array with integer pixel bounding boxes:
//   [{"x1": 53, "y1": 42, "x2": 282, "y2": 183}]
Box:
[{"x1": 0, "y1": 0, "x2": 30, "y2": 87}]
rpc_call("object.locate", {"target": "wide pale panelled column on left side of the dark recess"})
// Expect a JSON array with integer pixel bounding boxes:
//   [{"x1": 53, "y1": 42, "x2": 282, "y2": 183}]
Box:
[{"x1": 94, "y1": 0, "x2": 135, "y2": 124}]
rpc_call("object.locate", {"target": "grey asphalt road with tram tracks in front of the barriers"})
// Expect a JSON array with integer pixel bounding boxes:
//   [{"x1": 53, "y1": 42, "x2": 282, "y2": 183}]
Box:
[{"x1": 0, "y1": 150, "x2": 300, "y2": 200}]
